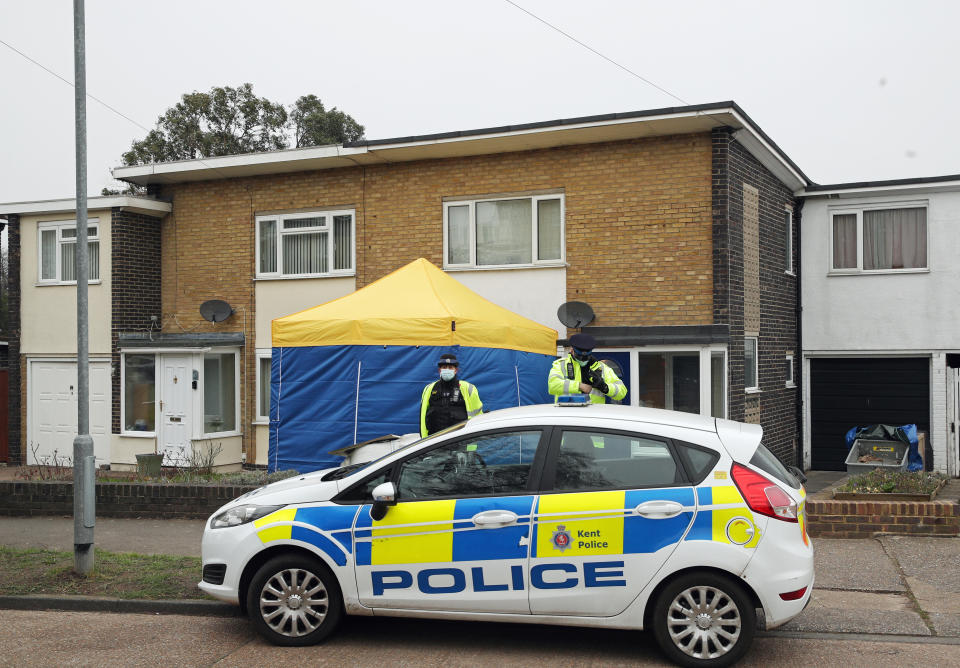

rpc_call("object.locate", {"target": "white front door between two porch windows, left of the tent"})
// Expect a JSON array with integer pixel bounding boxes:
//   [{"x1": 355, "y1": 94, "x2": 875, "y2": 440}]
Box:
[{"x1": 160, "y1": 355, "x2": 193, "y2": 466}]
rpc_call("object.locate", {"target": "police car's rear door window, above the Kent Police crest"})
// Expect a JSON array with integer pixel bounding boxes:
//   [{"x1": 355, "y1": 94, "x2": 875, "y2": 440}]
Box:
[{"x1": 553, "y1": 430, "x2": 683, "y2": 491}]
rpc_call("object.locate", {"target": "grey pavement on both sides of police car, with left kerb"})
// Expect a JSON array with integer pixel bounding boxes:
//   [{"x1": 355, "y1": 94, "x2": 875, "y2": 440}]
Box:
[{"x1": 0, "y1": 516, "x2": 960, "y2": 642}]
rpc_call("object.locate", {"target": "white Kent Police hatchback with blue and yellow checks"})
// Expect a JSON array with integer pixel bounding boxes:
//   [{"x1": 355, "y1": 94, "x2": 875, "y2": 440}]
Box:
[{"x1": 199, "y1": 404, "x2": 813, "y2": 666}]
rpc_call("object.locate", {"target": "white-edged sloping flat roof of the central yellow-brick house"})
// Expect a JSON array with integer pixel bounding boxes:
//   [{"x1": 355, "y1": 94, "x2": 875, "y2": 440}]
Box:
[{"x1": 111, "y1": 101, "x2": 810, "y2": 191}]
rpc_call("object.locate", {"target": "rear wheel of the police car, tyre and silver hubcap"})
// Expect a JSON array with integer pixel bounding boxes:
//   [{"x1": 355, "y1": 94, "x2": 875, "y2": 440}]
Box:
[{"x1": 651, "y1": 572, "x2": 757, "y2": 668}]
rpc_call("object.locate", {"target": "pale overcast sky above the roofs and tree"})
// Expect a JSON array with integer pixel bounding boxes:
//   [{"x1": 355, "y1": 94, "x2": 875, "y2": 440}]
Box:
[{"x1": 0, "y1": 0, "x2": 960, "y2": 202}]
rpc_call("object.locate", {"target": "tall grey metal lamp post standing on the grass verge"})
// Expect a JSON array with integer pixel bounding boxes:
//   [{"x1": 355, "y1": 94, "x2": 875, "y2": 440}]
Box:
[{"x1": 73, "y1": 0, "x2": 96, "y2": 575}]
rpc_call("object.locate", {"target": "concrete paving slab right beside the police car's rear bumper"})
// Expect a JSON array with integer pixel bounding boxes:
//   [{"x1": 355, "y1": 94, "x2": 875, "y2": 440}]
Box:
[{"x1": 813, "y1": 538, "x2": 915, "y2": 592}]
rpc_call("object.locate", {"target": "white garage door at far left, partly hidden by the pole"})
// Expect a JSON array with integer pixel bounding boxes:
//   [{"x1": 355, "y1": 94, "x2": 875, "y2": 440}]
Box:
[{"x1": 26, "y1": 361, "x2": 110, "y2": 466}]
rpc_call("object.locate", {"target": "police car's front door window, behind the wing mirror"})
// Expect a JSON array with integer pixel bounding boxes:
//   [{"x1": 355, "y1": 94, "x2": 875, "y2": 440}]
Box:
[{"x1": 397, "y1": 430, "x2": 542, "y2": 501}]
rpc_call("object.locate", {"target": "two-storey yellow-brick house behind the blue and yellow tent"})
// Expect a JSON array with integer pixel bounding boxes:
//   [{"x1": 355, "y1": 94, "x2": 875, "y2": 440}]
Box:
[{"x1": 0, "y1": 102, "x2": 809, "y2": 467}]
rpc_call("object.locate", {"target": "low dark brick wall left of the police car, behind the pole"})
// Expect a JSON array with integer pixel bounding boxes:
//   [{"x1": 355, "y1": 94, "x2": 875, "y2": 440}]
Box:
[{"x1": 0, "y1": 481, "x2": 254, "y2": 519}]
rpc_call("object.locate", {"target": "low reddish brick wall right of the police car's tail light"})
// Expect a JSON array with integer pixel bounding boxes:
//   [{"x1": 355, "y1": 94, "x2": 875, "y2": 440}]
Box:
[{"x1": 807, "y1": 498, "x2": 960, "y2": 538}]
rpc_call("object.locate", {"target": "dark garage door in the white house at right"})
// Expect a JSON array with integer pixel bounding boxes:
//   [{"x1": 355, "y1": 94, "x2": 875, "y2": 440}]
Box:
[{"x1": 810, "y1": 357, "x2": 930, "y2": 471}]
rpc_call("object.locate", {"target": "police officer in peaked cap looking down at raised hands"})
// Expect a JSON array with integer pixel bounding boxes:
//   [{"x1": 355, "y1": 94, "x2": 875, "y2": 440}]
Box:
[{"x1": 547, "y1": 333, "x2": 627, "y2": 404}]
